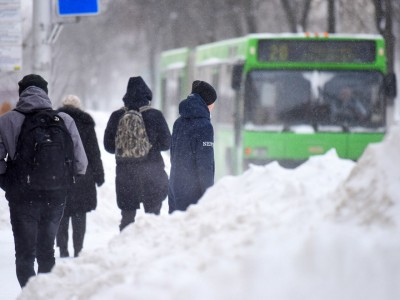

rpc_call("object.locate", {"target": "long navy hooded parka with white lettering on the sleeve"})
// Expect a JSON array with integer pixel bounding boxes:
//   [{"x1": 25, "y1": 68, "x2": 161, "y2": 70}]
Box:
[{"x1": 168, "y1": 94, "x2": 215, "y2": 212}]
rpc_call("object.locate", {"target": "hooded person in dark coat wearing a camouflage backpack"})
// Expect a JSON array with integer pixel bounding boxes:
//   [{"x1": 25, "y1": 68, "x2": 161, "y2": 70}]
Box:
[{"x1": 104, "y1": 76, "x2": 171, "y2": 231}]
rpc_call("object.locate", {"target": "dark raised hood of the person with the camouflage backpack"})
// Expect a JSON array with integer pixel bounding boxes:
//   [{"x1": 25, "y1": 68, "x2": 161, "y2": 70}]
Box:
[{"x1": 123, "y1": 76, "x2": 153, "y2": 108}]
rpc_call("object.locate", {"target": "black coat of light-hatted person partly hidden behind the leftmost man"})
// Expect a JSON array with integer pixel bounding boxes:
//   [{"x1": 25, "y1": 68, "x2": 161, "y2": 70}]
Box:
[{"x1": 58, "y1": 106, "x2": 104, "y2": 216}]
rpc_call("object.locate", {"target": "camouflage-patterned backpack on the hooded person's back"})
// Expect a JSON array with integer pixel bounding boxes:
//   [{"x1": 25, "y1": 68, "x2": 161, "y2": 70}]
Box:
[{"x1": 115, "y1": 106, "x2": 152, "y2": 161}]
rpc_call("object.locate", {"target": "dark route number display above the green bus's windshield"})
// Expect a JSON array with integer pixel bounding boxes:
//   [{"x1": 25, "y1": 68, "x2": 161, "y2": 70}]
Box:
[{"x1": 258, "y1": 40, "x2": 376, "y2": 63}]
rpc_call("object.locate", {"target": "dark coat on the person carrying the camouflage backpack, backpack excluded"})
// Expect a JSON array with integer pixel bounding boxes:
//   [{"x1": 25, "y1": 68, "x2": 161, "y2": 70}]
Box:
[{"x1": 104, "y1": 108, "x2": 171, "y2": 210}]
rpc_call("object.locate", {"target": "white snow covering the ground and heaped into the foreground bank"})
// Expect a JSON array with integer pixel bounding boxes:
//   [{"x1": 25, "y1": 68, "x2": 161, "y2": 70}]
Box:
[{"x1": 0, "y1": 112, "x2": 400, "y2": 300}]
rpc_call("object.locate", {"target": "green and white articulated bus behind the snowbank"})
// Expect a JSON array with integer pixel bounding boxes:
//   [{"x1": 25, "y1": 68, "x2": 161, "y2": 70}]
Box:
[{"x1": 159, "y1": 33, "x2": 396, "y2": 177}]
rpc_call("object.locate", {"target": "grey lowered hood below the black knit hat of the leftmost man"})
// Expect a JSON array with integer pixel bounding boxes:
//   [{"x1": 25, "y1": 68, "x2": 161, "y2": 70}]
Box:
[{"x1": 16, "y1": 86, "x2": 52, "y2": 113}]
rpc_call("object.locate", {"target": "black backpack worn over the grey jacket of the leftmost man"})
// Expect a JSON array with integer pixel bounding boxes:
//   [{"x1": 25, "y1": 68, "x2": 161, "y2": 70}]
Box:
[{"x1": 11, "y1": 110, "x2": 75, "y2": 191}]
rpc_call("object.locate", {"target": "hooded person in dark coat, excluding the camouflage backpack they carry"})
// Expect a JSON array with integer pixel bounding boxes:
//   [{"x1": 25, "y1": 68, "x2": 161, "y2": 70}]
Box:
[{"x1": 104, "y1": 76, "x2": 171, "y2": 231}]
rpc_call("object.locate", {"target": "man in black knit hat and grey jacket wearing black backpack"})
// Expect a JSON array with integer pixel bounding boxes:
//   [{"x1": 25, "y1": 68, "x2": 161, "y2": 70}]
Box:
[{"x1": 0, "y1": 74, "x2": 88, "y2": 287}]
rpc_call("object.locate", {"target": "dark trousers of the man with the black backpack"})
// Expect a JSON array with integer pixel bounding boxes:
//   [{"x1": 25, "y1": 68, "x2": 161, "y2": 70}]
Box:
[{"x1": 9, "y1": 199, "x2": 64, "y2": 287}]
